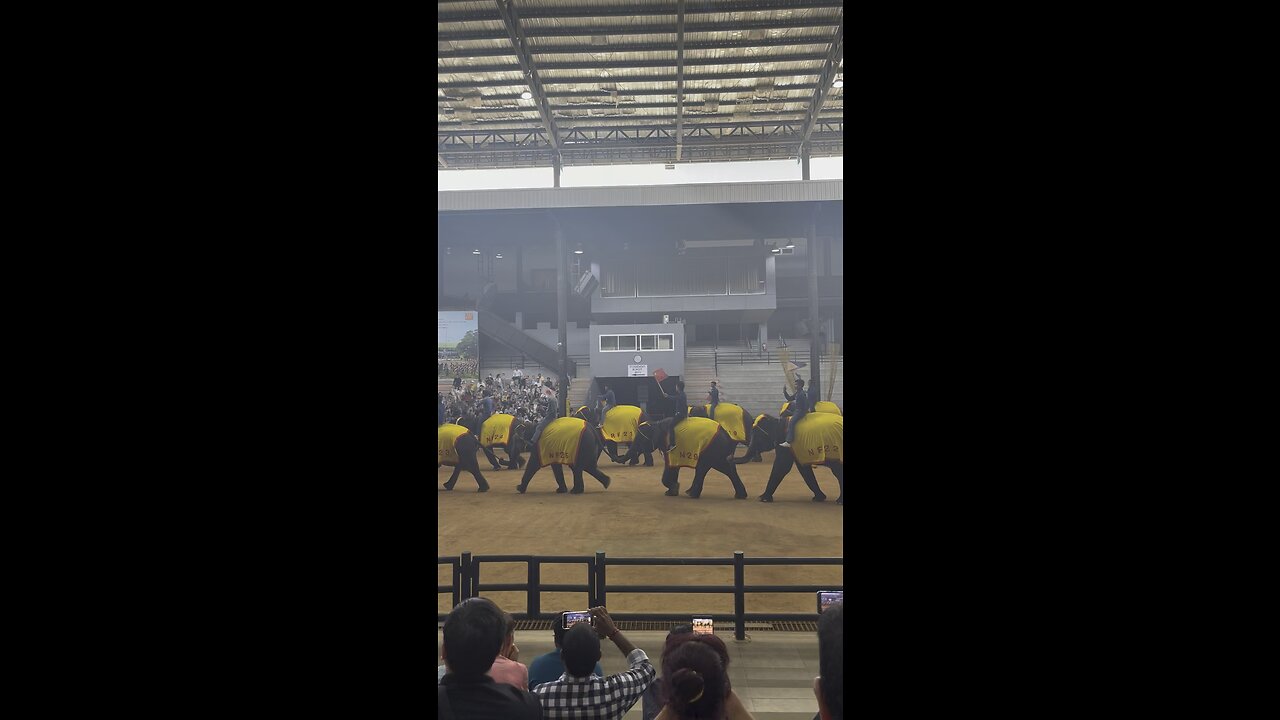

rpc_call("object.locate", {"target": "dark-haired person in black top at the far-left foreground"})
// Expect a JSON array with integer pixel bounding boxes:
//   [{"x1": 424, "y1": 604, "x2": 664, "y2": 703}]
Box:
[{"x1": 436, "y1": 597, "x2": 543, "y2": 720}]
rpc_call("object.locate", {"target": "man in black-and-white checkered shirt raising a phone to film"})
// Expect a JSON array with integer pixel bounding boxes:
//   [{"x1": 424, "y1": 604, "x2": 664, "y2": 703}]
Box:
[{"x1": 534, "y1": 607, "x2": 658, "y2": 720}]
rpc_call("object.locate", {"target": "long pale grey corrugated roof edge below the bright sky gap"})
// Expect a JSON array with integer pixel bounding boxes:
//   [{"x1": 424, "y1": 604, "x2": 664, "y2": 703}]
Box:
[{"x1": 435, "y1": 179, "x2": 845, "y2": 213}]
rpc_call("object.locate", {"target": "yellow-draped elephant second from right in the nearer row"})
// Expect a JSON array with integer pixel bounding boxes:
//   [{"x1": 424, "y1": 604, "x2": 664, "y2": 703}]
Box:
[{"x1": 631, "y1": 418, "x2": 748, "y2": 500}]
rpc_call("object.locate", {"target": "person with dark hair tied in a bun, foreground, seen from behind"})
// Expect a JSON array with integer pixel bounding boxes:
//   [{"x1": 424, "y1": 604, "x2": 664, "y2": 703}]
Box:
[{"x1": 657, "y1": 635, "x2": 754, "y2": 720}]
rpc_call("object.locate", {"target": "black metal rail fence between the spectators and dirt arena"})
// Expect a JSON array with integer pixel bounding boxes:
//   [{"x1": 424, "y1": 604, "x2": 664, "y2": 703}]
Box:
[{"x1": 436, "y1": 552, "x2": 845, "y2": 641}]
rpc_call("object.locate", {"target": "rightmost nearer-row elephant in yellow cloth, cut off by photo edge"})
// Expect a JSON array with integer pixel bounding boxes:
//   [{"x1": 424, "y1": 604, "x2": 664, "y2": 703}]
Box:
[{"x1": 735, "y1": 411, "x2": 845, "y2": 505}]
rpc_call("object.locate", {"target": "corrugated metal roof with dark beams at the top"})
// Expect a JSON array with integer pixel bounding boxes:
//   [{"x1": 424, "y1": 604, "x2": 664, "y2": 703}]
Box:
[{"x1": 436, "y1": 0, "x2": 844, "y2": 168}]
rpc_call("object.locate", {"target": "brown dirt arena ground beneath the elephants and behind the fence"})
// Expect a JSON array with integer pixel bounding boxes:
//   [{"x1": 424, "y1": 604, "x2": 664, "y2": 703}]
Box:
[{"x1": 436, "y1": 447, "x2": 845, "y2": 614}]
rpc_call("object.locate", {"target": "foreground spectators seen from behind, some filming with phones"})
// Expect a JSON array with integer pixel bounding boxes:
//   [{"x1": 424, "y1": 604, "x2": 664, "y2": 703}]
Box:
[{"x1": 436, "y1": 598, "x2": 845, "y2": 720}]
